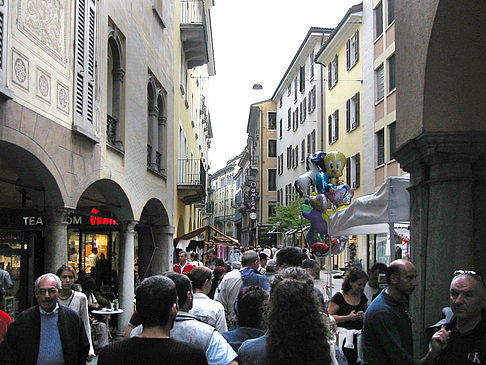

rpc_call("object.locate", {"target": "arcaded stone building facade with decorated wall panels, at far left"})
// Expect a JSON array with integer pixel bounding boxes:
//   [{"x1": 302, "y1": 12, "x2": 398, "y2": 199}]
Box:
[{"x1": 0, "y1": 0, "x2": 212, "y2": 334}]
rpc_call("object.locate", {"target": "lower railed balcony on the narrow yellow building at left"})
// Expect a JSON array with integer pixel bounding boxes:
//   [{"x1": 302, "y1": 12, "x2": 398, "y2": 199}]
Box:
[{"x1": 177, "y1": 158, "x2": 206, "y2": 205}]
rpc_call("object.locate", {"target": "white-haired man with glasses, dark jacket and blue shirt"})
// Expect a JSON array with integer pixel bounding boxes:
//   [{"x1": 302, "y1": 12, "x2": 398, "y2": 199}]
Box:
[{"x1": 0, "y1": 273, "x2": 89, "y2": 365}]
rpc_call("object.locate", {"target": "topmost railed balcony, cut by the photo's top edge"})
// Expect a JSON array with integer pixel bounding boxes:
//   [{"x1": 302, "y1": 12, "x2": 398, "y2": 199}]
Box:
[{"x1": 181, "y1": 0, "x2": 209, "y2": 68}]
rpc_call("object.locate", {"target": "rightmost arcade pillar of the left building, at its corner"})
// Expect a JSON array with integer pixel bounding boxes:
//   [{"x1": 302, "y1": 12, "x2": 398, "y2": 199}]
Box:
[{"x1": 147, "y1": 226, "x2": 175, "y2": 276}]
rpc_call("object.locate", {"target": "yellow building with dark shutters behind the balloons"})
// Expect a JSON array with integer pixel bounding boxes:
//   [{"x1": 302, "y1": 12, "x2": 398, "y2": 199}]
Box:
[{"x1": 316, "y1": 4, "x2": 366, "y2": 267}]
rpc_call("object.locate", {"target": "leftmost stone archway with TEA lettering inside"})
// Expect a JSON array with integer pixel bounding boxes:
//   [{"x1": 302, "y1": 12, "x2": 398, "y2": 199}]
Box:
[{"x1": 0, "y1": 141, "x2": 67, "y2": 311}]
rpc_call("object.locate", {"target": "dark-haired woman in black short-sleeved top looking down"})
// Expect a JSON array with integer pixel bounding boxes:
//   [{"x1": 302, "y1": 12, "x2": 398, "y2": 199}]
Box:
[{"x1": 329, "y1": 267, "x2": 368, "y2": 365}]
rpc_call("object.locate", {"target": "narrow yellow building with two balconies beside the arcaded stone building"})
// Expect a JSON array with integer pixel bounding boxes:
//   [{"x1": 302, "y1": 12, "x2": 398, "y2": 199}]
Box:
[{"x1": 172, "y1": 0, "x2": 215, "y2": 237}]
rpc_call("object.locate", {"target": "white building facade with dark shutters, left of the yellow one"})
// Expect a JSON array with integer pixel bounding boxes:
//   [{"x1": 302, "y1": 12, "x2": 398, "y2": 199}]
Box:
[{"x1": 272, "y1": 27, "x2": 332, "y2": 245}]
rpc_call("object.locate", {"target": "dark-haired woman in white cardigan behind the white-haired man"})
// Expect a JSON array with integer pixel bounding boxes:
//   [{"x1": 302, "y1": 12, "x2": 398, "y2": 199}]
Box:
[{"x1": 56, "y1": 265, "x2": 95, "y2": 358}]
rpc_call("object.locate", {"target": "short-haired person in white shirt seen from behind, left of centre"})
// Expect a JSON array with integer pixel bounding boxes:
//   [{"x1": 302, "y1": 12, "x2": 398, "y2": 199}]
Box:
[{"x1": 187, "y1": 266, "x2": 228, "y2": 333}]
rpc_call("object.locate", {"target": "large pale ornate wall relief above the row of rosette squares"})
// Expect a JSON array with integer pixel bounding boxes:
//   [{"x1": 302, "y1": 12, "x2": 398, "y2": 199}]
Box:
[{"x1": 18, "y1": 0, "x2": 69, "y2": 64}]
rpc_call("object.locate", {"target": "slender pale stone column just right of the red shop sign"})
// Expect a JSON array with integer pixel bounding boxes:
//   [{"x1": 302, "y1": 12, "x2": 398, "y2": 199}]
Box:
[{"x1": 116, "y1": 221, "x2": 137, "y2": 338}]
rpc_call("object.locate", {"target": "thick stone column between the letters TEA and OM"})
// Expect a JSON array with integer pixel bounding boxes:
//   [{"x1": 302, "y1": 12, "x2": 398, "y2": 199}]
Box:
[{"x1": 44, "y1": 208, "x2": 69, "y2": 274}]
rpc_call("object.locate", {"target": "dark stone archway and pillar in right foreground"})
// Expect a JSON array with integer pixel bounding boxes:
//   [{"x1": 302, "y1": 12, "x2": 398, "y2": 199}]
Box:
[{"x1": 396, "y1": 0, "x2": 486, "y2": 353}]
